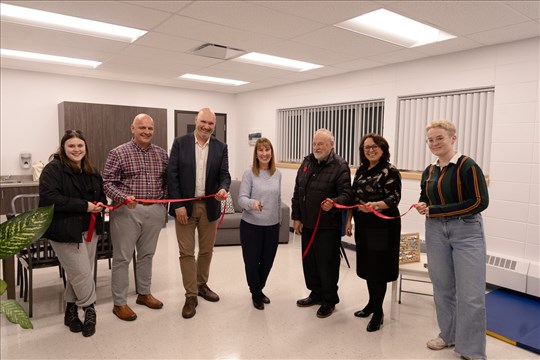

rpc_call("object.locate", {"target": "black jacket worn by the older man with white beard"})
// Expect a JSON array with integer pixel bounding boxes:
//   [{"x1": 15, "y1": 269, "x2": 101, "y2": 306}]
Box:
[{"x1": 291, "y1": 150, "x2": 352, "y2": 229}]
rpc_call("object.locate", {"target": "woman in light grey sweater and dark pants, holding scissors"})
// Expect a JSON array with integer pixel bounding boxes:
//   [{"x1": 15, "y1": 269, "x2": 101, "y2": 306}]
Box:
[{"x1": 238, "y1": 138, "x2": 282, "y2": 310}]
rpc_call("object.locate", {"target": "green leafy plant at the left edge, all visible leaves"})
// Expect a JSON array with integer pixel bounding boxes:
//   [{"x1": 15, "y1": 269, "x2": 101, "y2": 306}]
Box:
[{"x1": 0, "y1": 205, "x2": 54, "y2": 329}]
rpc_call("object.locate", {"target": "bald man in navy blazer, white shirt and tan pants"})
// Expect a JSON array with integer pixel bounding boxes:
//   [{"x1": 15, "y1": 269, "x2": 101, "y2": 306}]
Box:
[{"x1": 167, "y1": 108, "x2": 231, "y2": 319}]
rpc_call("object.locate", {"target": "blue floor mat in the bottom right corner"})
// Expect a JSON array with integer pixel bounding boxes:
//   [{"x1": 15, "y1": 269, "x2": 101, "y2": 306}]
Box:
[{"x1": 486, "y1": 289, "x2": 540, "y2": 354}]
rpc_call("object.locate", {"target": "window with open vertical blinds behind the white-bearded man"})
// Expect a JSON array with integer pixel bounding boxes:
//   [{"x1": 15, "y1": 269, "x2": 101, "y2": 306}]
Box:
[{"x1": 276, "y1": 100, "x2": 384, "y2": 166}]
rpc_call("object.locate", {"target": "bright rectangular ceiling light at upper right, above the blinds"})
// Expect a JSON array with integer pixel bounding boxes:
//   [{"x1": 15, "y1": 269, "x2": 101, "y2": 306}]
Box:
[{"x1": 335, "y1": 9, "x2": 455, "y2": 48}]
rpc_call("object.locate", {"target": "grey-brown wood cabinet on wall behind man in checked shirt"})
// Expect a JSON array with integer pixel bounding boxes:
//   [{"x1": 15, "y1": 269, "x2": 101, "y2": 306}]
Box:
[{"x1": 58, "y1": 101, "x2": 168, "y2": 172}]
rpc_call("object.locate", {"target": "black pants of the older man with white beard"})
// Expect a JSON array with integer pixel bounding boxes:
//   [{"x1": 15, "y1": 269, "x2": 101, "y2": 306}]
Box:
[{"x1": 302, "y1": 227, "x2": 341, "y2": 305}]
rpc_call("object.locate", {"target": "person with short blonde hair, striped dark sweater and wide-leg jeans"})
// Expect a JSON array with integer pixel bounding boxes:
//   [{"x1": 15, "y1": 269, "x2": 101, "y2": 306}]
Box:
[{"x1": 416, "y1": 120, "x2": 489, "y2": 359}]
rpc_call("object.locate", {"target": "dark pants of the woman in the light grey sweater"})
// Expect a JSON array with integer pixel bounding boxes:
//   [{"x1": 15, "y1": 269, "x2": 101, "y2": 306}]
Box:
[{"x1": 240, "y1": 220, "x2": 279, "y2": 298}]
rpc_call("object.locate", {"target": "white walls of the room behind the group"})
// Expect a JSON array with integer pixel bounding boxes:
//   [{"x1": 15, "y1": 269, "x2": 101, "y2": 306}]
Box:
[{"x1": 0, "y1": 38, "x2": 540, "y2": 263}]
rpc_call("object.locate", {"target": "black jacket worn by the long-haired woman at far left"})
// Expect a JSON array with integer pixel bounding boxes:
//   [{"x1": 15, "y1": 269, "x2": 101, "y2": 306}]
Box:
[{"x1": 39, "y1": 155, "x2": 107, "y2": 243}]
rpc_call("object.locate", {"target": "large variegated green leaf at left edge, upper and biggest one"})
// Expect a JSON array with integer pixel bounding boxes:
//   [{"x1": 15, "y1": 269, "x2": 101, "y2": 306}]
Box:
[{"x1": 0, "y1": 205, "x2": 54, "y2": 259}]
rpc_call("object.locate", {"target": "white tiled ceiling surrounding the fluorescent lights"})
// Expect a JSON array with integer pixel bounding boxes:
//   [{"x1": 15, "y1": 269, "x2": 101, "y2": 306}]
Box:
[{"x1": 0, "y1": 0, "x2": 540, "y2": 94}]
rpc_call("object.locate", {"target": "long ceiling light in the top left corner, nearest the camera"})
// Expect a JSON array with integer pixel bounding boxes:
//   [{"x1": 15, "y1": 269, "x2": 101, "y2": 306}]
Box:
[{"x1": 0, "y1": 3, "x2": 146, "y2": 43}]
